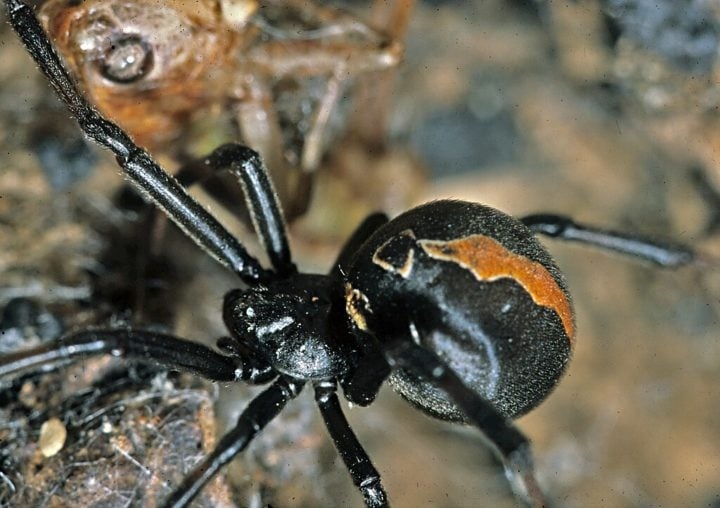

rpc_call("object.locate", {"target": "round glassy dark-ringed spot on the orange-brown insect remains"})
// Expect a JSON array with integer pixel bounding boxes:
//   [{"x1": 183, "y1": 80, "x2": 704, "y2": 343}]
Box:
[{"x1": 100, "y1": 34, "x2": 153, "y2": 83}]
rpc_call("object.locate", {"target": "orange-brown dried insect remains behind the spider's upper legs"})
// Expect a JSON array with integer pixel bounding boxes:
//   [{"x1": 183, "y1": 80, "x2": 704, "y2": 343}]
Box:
[{"x1": 39, "y1": 0, "x2": 412, "y2": 218}]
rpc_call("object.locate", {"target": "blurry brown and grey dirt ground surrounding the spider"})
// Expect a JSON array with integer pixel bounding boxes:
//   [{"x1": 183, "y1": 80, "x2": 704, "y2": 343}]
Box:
[{"x1": 0, "y1": 0, "x2": 720, "y2": 507}]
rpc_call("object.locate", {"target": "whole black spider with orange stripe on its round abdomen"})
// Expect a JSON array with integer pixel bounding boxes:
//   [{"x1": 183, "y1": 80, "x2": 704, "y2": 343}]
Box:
[{"x1": 0, "y1": 0, "x2": 703, "y2": 507}]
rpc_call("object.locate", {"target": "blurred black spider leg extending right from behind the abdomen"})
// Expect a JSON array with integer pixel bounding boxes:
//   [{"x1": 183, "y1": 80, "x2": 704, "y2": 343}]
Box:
[{"x1": 520, "y1": 214, "x2": 699, "y2": 268}]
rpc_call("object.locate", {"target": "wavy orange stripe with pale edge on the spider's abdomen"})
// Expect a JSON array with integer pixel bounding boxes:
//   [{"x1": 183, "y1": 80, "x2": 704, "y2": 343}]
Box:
[{"x1": 418, "y1": 235, "x2": 575, "y2": 343}]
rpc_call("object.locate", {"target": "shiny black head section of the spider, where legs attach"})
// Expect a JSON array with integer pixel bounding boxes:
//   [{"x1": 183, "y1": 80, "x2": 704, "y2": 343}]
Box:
[{"x1": 223, "y1": 275, "x2": 349, "y2": 380}]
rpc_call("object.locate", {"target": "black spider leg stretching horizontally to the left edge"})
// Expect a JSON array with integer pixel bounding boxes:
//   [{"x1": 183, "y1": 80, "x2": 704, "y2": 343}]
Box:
[{"x1": 0, "y1": 330, "x2": 238, "y2": 381}]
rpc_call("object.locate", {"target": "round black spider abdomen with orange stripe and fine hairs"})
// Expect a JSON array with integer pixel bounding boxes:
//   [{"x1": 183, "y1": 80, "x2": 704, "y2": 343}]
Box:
[{"x1": 346, "y1": 201, "x2": 574, "y2": 421}]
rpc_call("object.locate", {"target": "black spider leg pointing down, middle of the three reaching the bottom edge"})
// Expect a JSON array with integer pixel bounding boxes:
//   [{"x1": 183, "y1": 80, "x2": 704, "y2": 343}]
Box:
[{"x1": 314, "y1": 381, "x2": 388, "y2": 508}]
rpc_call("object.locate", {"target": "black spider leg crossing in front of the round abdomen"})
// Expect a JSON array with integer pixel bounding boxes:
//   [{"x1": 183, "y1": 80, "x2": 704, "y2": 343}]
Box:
[{"x1": 383, "y1": 340, "x2": 545, "y2": 508}]
